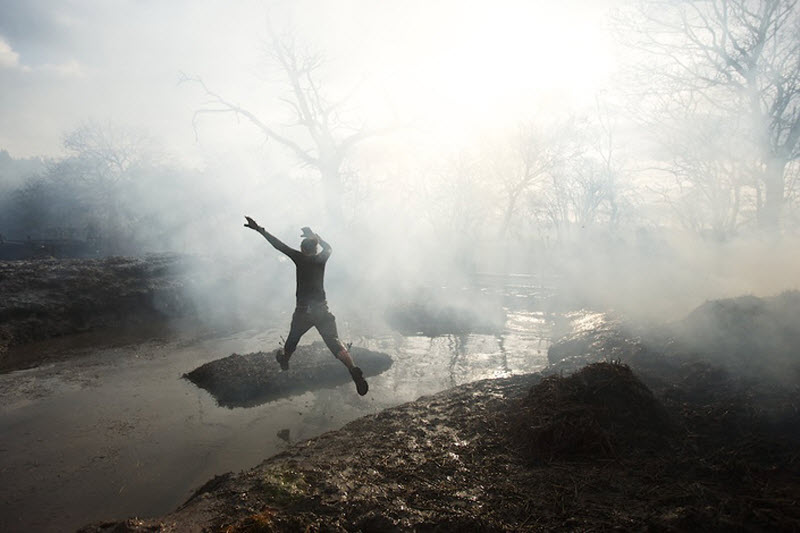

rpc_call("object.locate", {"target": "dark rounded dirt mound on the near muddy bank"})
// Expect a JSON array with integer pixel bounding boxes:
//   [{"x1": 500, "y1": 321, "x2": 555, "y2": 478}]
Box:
[{"x1": 515, "y1": 363, "x2": 671, "y2": 460}]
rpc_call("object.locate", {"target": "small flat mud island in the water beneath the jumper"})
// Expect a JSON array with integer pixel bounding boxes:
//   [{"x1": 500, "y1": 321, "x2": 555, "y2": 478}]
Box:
[{"x1": 183, "y1": 342, "x2": 392, "y2": 408}]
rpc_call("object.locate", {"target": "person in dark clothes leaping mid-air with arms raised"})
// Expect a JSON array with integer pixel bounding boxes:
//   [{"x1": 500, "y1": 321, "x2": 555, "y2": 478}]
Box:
[{"x1": 244, "y1": 216, "x2": 369, "y2": 396}]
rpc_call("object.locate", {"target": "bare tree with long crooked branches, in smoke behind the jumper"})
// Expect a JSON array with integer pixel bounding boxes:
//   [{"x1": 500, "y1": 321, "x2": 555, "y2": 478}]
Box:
[{"x1": 181, "y1": 27, "x2": 391, "y2": 220}]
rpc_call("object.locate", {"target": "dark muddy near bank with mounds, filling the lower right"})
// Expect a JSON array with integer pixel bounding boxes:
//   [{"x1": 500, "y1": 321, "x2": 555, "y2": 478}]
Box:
[{"x1": 83, "y1": 293, "x2": 800, "y2": 532}]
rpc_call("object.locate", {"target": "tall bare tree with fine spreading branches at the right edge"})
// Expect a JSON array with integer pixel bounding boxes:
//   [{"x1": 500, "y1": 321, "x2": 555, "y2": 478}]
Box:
[{"x1": 624, "y1": 0, "x2": 800, "y2": 229}]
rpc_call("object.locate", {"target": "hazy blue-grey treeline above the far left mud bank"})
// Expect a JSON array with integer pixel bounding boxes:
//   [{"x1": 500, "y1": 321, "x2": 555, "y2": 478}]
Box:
[{"x1": 0, "y1": 125, "x2": 209, "y2": 257}]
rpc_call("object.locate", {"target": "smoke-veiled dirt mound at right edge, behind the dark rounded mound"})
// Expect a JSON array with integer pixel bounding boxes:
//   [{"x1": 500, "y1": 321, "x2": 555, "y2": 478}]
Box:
[{"x1": 548, "y1": 292, "x2": 800, "y2": 468}]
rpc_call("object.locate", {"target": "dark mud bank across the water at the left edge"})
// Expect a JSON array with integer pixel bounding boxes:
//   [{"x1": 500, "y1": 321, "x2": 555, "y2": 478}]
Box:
[{"x1": 0, "y1": 255, "x2": 197, "y2": 372}]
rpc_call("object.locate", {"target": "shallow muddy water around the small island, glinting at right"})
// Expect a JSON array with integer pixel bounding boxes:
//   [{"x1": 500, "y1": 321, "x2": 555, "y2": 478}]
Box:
[{"x1": 0, "y1": 280, "x2": 583, "y2": 531}]
